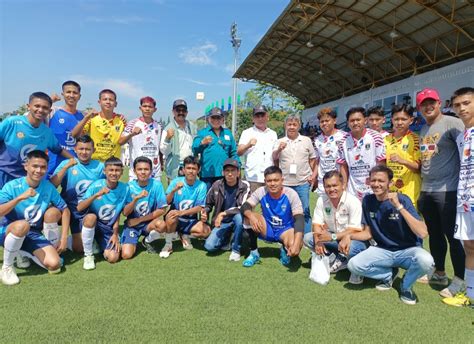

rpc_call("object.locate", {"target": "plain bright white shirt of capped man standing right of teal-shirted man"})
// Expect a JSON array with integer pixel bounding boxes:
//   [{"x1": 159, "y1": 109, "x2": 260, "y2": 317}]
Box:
[{"x1": 239, "y1": 126, "x2": 278, "y2": 183}]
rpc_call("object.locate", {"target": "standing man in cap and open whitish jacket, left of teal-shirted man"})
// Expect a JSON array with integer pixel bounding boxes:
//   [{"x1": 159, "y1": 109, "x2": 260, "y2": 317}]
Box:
[{"x1": 160, "y1": 99, "x2": 196, "y2": 181}]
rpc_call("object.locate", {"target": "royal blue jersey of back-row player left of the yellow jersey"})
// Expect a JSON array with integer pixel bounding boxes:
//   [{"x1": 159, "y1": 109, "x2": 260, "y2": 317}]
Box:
[{"x1": 48, "y1": 109, "x2": 84, "y2": 175}]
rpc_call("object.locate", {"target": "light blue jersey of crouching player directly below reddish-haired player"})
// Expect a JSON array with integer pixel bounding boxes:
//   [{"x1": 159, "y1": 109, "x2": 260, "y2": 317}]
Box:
[{"x1": 126, "y1": 179, "x2": 168, "y2": 229}]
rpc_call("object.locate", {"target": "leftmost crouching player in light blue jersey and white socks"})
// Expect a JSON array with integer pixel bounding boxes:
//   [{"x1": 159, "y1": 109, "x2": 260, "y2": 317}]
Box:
[{"x1": 0, "y1": 150, "x2": 71, "y2": 285}]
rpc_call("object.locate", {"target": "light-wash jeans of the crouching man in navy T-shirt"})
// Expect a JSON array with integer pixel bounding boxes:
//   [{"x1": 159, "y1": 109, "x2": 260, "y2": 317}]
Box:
[{"x1": 347, "y1": 246, "x2": 434, "y2": 291}]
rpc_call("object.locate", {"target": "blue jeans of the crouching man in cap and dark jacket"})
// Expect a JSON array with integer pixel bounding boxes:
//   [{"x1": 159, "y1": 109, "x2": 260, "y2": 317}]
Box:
[{"x1": 204, "y1": 213, "x2": 243, "y2": 253}]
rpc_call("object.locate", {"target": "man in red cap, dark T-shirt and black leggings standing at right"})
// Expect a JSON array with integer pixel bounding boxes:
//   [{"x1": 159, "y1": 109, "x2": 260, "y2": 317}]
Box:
[{"x1": 416, "y1": 88, "x2": 465, "y2": 297}]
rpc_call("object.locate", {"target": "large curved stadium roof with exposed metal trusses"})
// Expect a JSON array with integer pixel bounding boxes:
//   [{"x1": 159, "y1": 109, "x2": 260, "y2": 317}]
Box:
[{"x1": 234, "y1": 0, "x2": 474, "y2": 107}]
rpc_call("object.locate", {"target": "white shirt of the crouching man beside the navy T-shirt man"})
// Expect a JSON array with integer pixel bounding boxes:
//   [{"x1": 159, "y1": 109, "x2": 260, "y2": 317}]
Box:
[{"x1": 313, "y1": 191, "x2": 362, "y2": 233}]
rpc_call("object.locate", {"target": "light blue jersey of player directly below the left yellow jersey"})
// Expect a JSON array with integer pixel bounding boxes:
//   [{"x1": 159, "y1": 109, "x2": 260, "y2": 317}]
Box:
[{"x1": 53, "y1": 158, "x2": 105, "y2": 218}]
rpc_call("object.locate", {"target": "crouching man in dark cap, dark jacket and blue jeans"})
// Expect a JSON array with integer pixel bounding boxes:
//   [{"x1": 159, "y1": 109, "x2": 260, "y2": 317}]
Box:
[{"x1": 204, "y1": 159, "x2": 250, "y2": 262}]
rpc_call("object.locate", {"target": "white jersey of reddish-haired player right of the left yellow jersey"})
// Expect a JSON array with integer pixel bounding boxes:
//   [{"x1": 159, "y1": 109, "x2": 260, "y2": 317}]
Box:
[{"x1": 122, "y1": 117, "x2": 161, "y2": 180}]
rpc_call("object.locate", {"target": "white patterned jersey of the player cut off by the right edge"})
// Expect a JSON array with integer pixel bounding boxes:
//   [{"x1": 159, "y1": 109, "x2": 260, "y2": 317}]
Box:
[{"x1": 456, "y1": 127, "x2": 474, "y2": 213}]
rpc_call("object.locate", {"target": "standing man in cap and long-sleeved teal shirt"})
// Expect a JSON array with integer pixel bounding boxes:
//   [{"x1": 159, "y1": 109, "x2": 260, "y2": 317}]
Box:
[{"x1": 193, "y1": 107, "x2": 240, "y2": 189}]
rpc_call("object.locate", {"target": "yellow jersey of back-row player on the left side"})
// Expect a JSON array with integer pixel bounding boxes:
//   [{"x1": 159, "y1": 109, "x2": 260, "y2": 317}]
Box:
[{"x1": 84, "y1": 114, "x2": 125, "y2": 162}]
